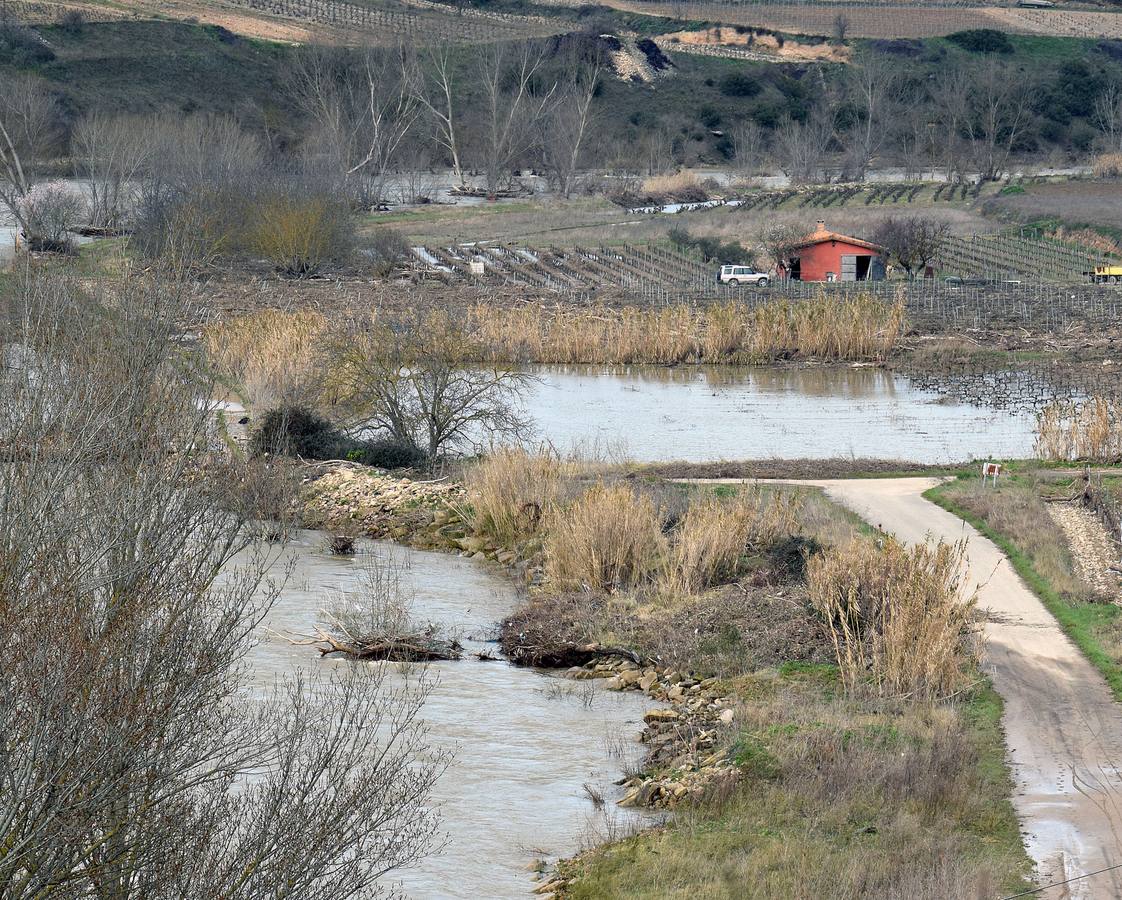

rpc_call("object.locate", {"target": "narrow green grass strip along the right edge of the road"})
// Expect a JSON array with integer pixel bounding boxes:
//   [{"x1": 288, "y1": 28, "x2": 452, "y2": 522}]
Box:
[{"x1": 923, "y1": 483, "x2": 1122, "y2": 700}]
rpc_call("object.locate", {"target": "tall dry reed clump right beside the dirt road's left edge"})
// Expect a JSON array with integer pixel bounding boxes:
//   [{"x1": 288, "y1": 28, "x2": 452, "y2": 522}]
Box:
[{"x1": 807, "y1": 539, "x2": 976, "y2": 699}]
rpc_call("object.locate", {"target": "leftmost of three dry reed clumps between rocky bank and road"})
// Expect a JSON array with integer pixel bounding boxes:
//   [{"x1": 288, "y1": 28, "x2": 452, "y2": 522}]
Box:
[{"x1": 465, "y1": 447, "x2": 573, "y2": 548}]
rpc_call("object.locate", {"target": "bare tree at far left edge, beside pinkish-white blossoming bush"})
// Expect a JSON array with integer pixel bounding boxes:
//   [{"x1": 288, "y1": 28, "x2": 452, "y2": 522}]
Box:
[{"x1": 0, "y1": 75, "x2": 58, "y2": 233}]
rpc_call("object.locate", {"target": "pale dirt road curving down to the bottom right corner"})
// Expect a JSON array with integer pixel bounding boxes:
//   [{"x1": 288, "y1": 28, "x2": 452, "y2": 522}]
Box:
[{"x1": 686, "y1": 478, "x2": 1122, "y2": 900}]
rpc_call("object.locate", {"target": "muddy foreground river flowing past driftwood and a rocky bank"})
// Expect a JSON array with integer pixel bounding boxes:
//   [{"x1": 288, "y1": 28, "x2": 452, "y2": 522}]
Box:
[{"x1": 250, "y1": 532, "x2": 654, "y2": 900}]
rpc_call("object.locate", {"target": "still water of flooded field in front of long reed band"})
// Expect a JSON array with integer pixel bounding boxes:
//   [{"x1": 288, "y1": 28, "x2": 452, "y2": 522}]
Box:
[{"x1": 525, "y1": 367, "x2": 1034, "y2": 463}]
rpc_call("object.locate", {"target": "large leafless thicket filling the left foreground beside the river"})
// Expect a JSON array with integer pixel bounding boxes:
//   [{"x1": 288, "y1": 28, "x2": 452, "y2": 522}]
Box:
[{"x1": 0, "y1": 274, "x2": 444, "y2": 900}]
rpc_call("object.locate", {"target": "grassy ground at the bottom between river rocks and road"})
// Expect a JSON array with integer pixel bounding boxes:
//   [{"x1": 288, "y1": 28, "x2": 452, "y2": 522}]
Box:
[{"x1": 564, "y1": 665, "x2": 1030, "y2": 900}]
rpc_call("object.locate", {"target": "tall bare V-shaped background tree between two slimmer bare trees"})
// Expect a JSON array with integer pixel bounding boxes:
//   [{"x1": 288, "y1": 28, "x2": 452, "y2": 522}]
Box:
[{"x1": 476, "y1": 40, "x2": 559, "y2": 194}]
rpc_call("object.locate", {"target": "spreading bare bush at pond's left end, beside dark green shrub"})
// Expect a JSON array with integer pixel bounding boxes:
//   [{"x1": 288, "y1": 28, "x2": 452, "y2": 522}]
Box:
[{"x1": 329, "y1": 313, "x2": 533, "y2": 463}]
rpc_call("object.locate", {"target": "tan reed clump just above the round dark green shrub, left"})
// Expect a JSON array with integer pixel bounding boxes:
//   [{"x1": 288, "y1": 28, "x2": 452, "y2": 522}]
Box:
[{"x1": 203, "y1": 310, "x2": 327, "y2": 410}]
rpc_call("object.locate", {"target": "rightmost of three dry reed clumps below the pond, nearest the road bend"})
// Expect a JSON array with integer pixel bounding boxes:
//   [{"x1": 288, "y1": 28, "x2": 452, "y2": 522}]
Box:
[{"x1": 661, "y1": 490, "x2": 800, "y2": 596}]
